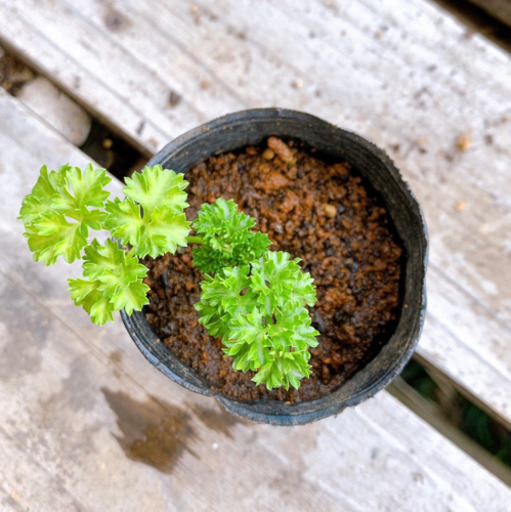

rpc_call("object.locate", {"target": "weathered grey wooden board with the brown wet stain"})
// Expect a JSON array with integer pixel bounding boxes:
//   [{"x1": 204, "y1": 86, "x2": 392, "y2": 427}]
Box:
[{"x1": 0, "y1": 86, "x2": 511, "y2": 512}]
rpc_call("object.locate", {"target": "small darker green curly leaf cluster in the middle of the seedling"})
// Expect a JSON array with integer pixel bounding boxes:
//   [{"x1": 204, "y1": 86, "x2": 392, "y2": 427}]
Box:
[{"x1": 193, "y1": 198, "x2": 271, "y2": 274}]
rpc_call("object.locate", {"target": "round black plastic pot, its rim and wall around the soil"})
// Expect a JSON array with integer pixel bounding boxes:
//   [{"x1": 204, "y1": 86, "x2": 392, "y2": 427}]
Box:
[{"x1": 122, "y1": 108, "x2": 427, "y2": 425}]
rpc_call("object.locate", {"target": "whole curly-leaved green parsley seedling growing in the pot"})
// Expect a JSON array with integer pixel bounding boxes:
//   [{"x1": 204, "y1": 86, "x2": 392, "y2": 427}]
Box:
[{"x1": 19, "y1": 164, "x2": 319, "y2": 389}]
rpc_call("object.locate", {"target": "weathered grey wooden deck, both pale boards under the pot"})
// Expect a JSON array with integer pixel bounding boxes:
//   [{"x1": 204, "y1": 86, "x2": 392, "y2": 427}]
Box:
[{"x1": 0, "y1": 0, "x2": 511, "y2": 512}]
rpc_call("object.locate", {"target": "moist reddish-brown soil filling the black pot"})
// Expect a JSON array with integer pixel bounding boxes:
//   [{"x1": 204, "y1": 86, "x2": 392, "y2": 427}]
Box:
[{"x1": 145, "y1": 140, "x2": 402, "y2": 402}]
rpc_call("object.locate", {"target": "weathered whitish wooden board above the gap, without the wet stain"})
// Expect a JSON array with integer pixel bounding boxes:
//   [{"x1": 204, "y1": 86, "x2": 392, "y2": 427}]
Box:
[{"x1": 0, "y1": 0, "x2": 511, "y2": 426}]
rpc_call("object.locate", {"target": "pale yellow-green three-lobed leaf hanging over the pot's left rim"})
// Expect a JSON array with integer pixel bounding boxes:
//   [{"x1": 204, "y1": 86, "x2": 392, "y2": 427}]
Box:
[{"x1": 19, "y1": 164, "x2": 190, "y2": 325}]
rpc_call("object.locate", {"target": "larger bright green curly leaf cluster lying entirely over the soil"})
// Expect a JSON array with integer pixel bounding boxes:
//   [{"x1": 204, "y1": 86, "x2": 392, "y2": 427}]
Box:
[{"x1": 195, "y1": 251, "x2": 319, "y2": 389}]
